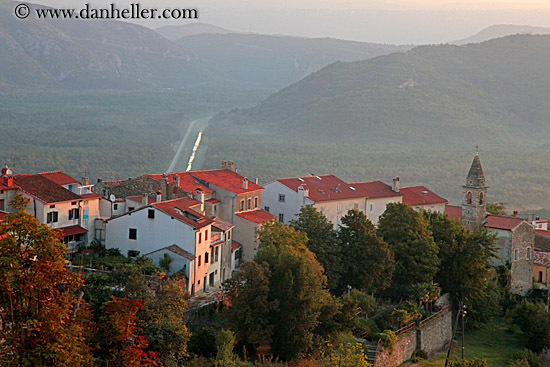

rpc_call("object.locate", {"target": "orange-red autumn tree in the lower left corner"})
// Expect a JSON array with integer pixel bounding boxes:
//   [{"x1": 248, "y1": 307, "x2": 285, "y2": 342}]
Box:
[{"x1": 0, "y1": 195, "x2": 93, "y2": 366}]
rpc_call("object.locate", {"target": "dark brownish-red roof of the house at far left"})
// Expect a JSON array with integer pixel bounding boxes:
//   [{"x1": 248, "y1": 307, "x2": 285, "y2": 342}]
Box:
[{"x1": 13, "y1": 173, "x2": 81, "y2": 204}]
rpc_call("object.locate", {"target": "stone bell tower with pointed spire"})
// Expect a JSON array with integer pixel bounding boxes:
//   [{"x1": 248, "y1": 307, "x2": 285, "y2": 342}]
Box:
[{"x1": 462, "y1": 151, "x2": 487, "y2": 231}]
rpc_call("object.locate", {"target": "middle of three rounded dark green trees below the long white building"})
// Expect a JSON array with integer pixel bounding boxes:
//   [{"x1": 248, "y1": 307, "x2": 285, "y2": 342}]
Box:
[{"x1": 338, "y1": 209, "x2": 394, "y2": 291}]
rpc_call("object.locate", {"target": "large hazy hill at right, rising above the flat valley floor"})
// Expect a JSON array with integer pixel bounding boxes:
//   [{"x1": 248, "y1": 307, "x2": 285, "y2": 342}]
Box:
[{"x1": 216, "y1": 35, "x2": 550, "y2": 147}]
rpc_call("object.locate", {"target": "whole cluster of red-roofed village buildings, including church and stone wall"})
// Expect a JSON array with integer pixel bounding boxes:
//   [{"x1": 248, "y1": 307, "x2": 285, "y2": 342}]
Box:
[{"x1": 0, "y1": 153, "x2": 550, "y2": 366}]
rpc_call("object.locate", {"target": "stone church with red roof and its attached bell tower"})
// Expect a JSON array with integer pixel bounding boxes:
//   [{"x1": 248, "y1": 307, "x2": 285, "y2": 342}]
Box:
[{"x1": 445, "y1": 153, "x2": 543, "y2": 295}]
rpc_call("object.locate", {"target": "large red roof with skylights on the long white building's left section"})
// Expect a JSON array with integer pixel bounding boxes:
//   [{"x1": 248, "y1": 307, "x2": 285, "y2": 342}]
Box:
[{"x1": 277, "y1": 175, "x2": 363, "y2": 202}]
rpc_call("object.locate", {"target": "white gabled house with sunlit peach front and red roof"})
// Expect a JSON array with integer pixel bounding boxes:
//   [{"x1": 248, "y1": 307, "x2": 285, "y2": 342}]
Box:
[{"x1": 105, "y1": 198, "x2": 219, "y2": 294}]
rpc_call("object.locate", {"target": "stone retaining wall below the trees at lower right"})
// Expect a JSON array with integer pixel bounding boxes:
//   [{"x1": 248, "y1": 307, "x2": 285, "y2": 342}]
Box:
[{"x1": 374, "y1": 311, "x2": 453, "y2": 367}]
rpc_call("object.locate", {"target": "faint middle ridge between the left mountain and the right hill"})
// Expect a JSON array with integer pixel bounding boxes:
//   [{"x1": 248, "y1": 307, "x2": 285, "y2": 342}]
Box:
[{"x1": 176, "y1": 33, "x2": 412, "y2": 89}]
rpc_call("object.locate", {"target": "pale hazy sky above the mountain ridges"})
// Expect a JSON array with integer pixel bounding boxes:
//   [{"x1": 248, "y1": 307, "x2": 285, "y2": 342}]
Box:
[{"x1": 30, "y1": 0, "x2": 550, "y2": 44}]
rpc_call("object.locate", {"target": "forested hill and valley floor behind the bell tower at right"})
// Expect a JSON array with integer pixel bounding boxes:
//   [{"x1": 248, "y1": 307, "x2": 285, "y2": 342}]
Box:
[{"x1": 207, "y1": 36, "x2": 550, "y2": 207}]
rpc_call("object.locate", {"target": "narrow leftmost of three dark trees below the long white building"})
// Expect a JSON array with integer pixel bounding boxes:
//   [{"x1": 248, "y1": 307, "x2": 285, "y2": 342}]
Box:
[{"x1": 290, "y1": 205, "x2": 342, "y2": 289}]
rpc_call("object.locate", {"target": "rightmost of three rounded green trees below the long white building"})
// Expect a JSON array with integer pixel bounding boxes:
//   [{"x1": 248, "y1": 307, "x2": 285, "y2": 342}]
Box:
[{"x1": 378, "y1": 203, "x2": 439, "y2": 286}]
